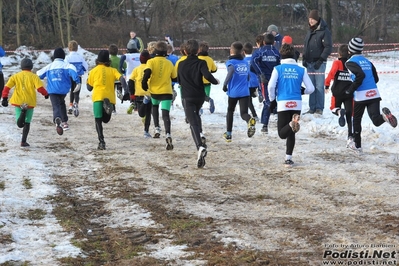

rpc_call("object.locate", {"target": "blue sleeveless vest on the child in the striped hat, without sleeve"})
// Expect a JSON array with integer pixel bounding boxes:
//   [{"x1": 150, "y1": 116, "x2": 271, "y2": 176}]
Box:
[{"x1": 347, "y1": 54, "x2": 381, "y2": 101}]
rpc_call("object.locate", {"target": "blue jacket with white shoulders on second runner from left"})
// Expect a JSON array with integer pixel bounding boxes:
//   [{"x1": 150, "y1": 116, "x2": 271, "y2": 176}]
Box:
[{"x1": 36, "y1": 58, "x2": 80, "y2": 95}]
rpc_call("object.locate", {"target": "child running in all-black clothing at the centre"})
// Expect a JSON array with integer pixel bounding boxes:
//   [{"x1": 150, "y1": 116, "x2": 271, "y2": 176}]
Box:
[{"x1": 177, "y1": 40, "x2": 219, "y2": 168}]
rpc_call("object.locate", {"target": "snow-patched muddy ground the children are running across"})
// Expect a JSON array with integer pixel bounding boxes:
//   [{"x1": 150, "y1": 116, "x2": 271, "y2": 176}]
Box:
[{"x1": 0, "y1": 46, "x2": 399, "y2": 265}]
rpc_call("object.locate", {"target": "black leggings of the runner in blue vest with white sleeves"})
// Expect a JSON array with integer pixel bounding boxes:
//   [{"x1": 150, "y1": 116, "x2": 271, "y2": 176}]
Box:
[{"x1": 277, "y1": 110, "x2": 301, "y2": 155}]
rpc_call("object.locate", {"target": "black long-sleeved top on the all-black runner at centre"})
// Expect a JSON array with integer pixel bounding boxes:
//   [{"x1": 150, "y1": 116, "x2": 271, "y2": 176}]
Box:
[{"x1": 177, "y1": 55, "x2": 218, "y2": 99}]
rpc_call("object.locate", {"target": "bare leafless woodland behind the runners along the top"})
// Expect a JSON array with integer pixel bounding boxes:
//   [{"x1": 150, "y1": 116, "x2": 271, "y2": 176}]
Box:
[{"x1": 0, "y1": 0, "x2": 399, "y2": 59}]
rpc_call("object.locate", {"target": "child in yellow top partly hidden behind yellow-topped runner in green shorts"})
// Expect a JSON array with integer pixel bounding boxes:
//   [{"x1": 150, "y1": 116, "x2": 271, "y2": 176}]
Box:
[{"x1": 128, "y1": 50, "x2": 152, "y2": 138}]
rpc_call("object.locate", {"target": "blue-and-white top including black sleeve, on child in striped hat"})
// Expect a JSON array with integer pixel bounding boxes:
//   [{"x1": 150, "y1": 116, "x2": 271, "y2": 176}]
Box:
[{"x1": 346, "y1": 54, "x2": 381, "y2": 102}]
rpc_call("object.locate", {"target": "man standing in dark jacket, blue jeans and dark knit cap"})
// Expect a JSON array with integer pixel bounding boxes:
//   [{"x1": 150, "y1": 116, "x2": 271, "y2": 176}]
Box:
[{"x1": 302, "y1": 10, "x2": 332, "y2": 115}]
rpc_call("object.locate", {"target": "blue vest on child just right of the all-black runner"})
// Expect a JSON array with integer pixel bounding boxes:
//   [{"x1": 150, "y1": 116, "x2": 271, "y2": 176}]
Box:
[{"x1": 226, "y1": 59, "x2": 249, "y2": 98}]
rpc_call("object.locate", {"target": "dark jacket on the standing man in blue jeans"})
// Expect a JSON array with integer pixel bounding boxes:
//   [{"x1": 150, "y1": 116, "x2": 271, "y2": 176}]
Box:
[{"x1": 303, "y1": 18, "x2": 332, "y2": 63}]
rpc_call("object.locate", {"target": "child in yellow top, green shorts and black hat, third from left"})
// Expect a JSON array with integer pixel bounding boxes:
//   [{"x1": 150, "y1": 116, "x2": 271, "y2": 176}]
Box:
[{"x1": 87, "y1": 50, "x2": 127, "y2": 150}]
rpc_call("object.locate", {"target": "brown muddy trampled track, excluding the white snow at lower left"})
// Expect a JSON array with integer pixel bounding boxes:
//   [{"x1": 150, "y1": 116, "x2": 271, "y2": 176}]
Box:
[{"x1": 0, "y1": 95, "x2": 399, "y2": 265}]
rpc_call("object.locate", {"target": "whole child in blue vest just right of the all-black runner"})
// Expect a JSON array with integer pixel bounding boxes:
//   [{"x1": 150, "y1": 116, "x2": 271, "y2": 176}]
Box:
[{"x1": 223, "y1": 42, "x2": 256, "y2": 142}]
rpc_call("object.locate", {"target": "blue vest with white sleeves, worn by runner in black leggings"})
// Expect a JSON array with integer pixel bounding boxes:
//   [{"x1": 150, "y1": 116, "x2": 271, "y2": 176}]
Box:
[{"x1": 267, "y1": 58, "x2": 314, "y2": 112}]
